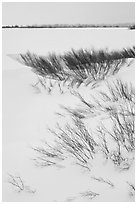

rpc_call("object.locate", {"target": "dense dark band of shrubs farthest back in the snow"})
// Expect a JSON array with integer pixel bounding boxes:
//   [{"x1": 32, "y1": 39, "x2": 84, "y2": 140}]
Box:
[{"x1": 12, "y1": 47, "x2": 135, "y2": 93}]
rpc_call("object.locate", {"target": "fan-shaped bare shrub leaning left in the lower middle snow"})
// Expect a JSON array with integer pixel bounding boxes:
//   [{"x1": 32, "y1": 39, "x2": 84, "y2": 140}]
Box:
[{"x1": 33, "y1": 117, "x2": 97, "y2": 170}]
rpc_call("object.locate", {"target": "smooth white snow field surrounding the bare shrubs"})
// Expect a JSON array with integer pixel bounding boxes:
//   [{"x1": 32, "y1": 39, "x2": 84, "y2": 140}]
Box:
[{"x1": 3, "y1": 29, "x2": 135, "y2": 202}]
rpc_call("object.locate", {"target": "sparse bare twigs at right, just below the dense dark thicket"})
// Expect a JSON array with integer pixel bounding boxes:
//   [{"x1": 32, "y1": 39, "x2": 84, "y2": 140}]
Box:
[{"x1": 68, "y1": 79, "x2": 135, "y2": 118}]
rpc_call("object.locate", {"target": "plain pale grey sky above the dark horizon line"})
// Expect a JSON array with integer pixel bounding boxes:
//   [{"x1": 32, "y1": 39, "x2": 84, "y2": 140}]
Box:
[{"x1": 2, "y1": 2, "x2": 135, "y2": 25}]
